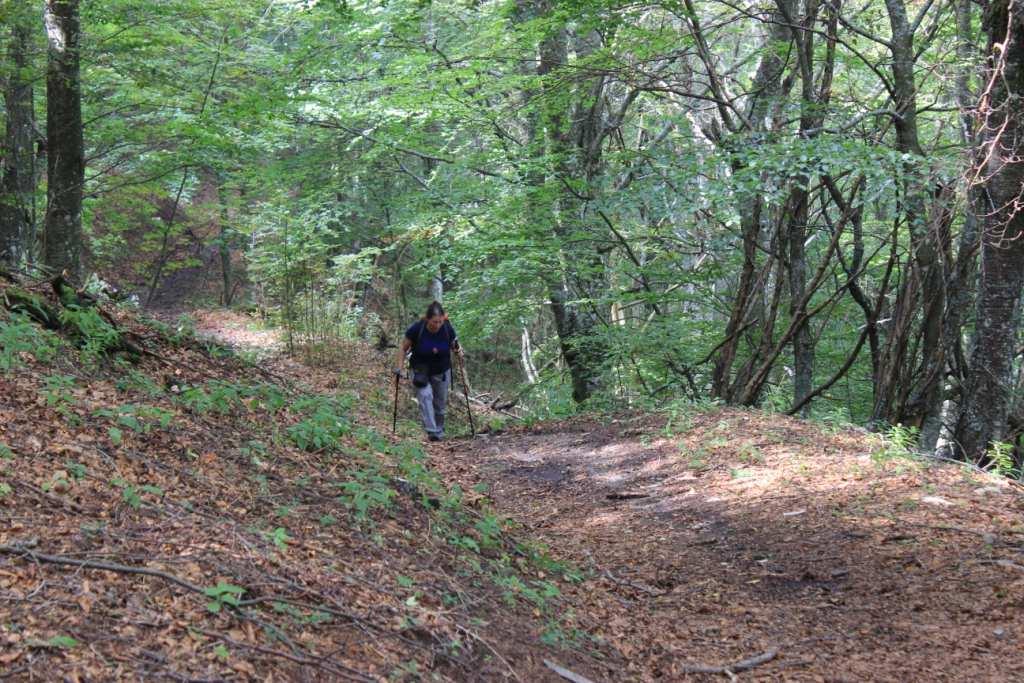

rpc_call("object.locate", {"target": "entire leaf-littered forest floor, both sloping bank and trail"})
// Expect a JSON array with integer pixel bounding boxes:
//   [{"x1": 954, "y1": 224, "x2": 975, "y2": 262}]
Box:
[{"x1": 0, "y1": 296, "x2": 1024, "y2": 682}]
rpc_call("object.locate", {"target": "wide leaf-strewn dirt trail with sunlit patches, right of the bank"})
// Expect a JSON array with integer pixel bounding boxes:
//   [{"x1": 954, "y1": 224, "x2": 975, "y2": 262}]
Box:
[{"x1": 433, "y1": 410, "x2": 1024, "y2": 681}]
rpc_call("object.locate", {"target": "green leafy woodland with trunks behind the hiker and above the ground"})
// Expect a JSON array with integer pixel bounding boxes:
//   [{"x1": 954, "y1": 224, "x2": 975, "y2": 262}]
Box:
[{"x1": 0, "y1": 0, "x2": 1024, "y2": 475}]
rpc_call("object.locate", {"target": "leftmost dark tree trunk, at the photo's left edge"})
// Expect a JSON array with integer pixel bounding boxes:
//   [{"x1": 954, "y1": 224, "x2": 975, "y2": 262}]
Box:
[{"x1": 0, "y1": 17, "x2": 36, "y2": 265}]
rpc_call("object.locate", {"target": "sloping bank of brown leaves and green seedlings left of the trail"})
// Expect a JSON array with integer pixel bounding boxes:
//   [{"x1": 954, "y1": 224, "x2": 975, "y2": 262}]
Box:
[{"x1": 0, "y1": 283, "x2": 614, "y2": 681}]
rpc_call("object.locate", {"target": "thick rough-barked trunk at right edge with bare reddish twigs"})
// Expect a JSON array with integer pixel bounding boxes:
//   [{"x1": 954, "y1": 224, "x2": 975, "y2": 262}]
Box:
[{"x1": 954, "y1": 0, "x2": 1024, "y2": 460}]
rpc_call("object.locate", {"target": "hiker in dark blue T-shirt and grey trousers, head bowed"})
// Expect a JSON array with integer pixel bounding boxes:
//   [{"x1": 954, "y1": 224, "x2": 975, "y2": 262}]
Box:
[{"x1": 394, "y1": 301, "x2": 463, "y2": 441}]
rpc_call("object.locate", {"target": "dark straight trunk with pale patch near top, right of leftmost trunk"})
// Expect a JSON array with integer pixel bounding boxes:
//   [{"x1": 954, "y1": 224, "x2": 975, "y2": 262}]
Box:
[{"x1": 43, "y1": 0, "x2": 85, "y2": 280}]
